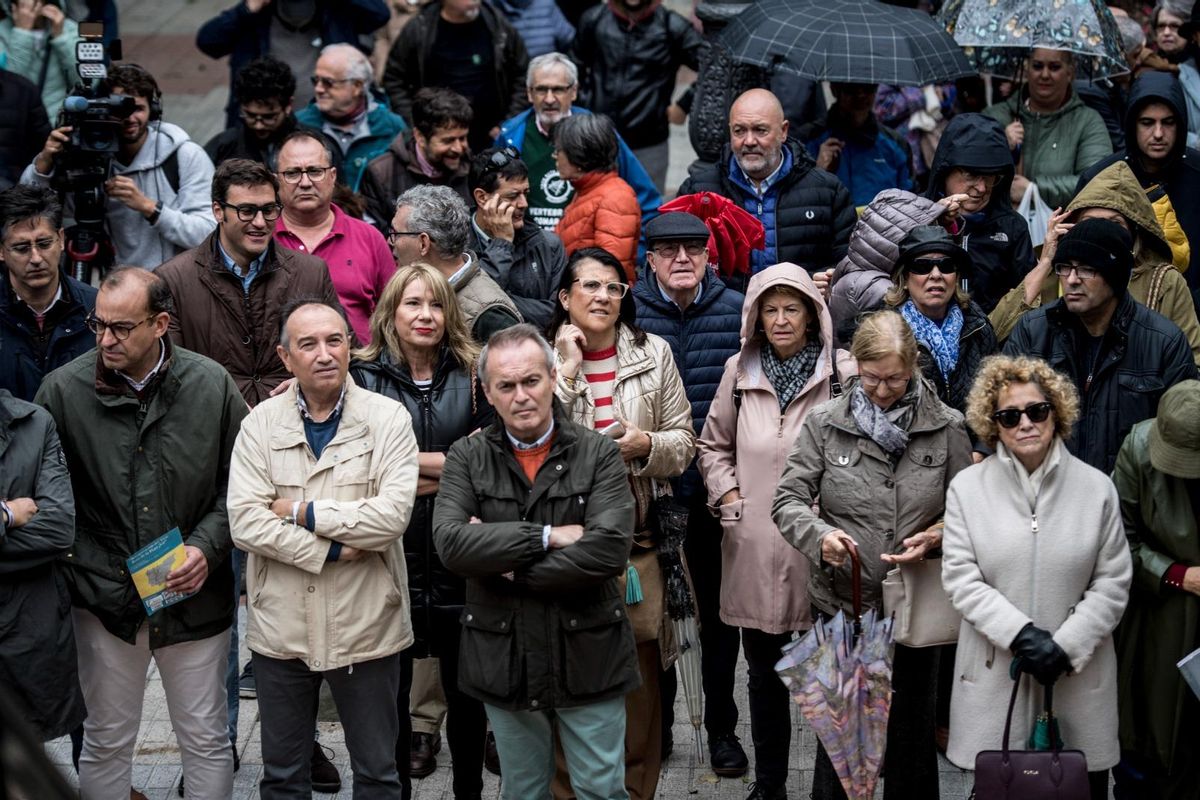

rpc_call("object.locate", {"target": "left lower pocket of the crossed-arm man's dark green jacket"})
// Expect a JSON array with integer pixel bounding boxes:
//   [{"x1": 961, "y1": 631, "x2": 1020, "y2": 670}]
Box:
[{"x1": 458, "y1": 606, "x2": 521, "y2": 700}]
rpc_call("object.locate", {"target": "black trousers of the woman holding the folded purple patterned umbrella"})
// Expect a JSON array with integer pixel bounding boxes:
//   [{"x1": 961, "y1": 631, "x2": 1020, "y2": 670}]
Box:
[{"x1": 812, "y1": 644, "x2": 938, "y2": 800}]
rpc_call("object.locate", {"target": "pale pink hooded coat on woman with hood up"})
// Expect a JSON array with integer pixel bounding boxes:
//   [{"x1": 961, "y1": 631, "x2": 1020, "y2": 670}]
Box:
[{"x1": 697, "y1": 264, "x2": 834, "y2": 633}]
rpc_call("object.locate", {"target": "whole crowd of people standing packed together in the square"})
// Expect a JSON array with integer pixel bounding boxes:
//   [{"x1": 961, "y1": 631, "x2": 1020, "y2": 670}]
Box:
[{"x1": 0, "y1": 0, "x2": 1200, "y2": 800}]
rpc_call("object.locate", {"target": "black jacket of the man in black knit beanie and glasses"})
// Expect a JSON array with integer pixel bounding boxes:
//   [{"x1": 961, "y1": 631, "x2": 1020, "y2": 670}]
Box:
[{"x1": 1004, "y1": 291, "x2": 1196, "y2": 475}]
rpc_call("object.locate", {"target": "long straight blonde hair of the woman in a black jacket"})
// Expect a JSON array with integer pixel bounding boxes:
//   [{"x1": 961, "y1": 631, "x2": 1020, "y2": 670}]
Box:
[{"x1": 353, "y1": 261, "x2": 479, "y2": 371}]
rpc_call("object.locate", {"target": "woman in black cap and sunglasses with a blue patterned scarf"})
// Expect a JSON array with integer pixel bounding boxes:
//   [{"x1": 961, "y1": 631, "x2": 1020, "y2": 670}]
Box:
[{"x1": 884, "y1": 225, "x2": 1000, "y2": 424}]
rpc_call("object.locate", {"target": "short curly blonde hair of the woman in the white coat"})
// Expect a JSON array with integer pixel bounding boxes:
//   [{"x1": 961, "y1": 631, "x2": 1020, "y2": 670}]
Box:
[{"x1": 966, "y1": 355, "x2": 1079, "y2": 447}]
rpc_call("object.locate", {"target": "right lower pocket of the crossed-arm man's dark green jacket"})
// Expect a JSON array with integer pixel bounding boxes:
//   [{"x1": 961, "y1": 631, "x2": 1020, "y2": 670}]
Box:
[{"x1": 560, "y1": 600, "x2": 636, "y2": 698}]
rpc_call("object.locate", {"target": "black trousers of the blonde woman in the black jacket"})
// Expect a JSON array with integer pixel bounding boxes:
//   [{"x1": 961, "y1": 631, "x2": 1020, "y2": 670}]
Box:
[{"x1": 396, "y1": 625, "x2": 487, "y2": 800}]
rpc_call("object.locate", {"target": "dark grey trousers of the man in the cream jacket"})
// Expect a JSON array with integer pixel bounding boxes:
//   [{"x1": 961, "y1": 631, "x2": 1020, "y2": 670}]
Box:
[{"x1": 252, "y1": 652, "x2": 413, "y2": 800}]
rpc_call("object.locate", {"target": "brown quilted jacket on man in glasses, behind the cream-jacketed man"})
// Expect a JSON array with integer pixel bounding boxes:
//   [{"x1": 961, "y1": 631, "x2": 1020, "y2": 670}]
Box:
[{"x1": 155, "y1": 231, "x2": 353, "y2": 408}]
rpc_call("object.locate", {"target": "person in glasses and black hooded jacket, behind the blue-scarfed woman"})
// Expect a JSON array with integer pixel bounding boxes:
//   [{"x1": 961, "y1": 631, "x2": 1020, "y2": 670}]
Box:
[{"x1": 925, "y1": 114, "x2": 1036, "y2": 313}]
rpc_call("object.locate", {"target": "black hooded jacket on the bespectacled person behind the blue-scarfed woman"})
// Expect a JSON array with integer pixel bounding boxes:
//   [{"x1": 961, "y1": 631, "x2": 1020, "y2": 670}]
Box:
[{"x1": 925, "y1": 114, "x2": 1036, "y2": 312}]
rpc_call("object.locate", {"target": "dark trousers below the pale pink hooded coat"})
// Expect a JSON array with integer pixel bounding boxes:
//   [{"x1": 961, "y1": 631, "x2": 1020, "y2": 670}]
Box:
[{"x1": 742, "y1": 627, "x2": 792, "y2": 789}]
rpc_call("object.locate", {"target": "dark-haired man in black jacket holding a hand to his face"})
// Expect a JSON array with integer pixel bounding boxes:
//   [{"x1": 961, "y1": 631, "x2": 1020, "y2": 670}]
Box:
[{"x1": 470, "y1": 148, "x2": 566, "y2": 330}]
